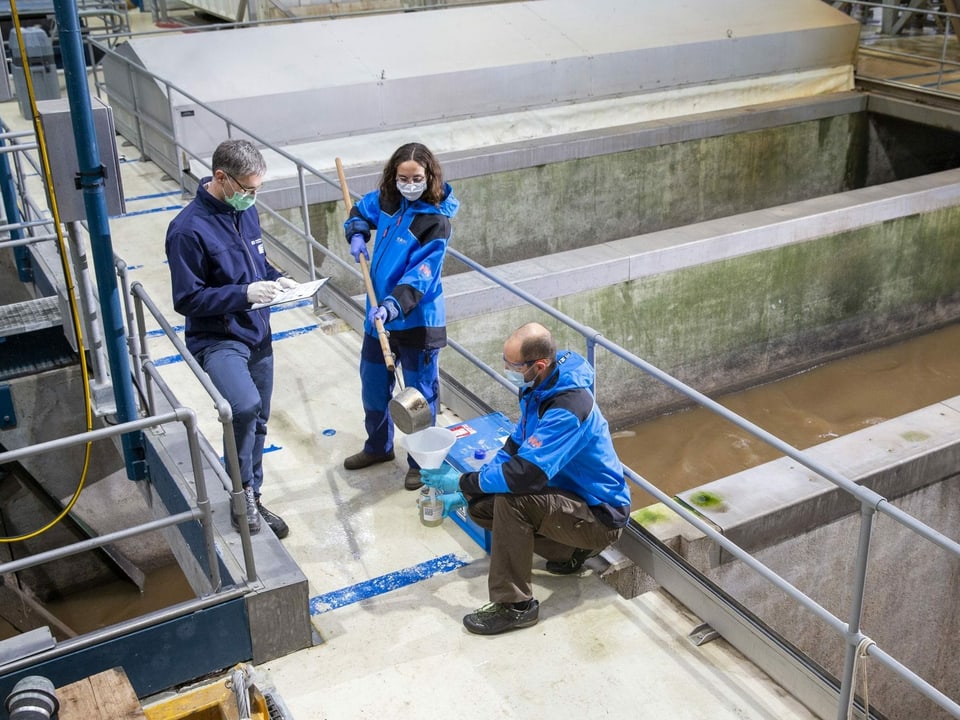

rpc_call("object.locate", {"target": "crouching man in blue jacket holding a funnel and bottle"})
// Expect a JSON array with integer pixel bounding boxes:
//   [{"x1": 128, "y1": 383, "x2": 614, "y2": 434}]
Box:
[{"x1": 421, "y1": 323, "x2": 630, "y2": 635}]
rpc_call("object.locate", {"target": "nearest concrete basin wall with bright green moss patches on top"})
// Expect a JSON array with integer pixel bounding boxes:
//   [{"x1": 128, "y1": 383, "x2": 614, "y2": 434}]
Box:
[{"x1": 634, "y1": 398, "x2": 960, "y2": 720}]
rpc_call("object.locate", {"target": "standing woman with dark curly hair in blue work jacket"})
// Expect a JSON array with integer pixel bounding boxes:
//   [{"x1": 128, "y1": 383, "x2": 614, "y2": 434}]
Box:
[{"x1": 343, "y1": 143, "x2": 460, "y2": 490}]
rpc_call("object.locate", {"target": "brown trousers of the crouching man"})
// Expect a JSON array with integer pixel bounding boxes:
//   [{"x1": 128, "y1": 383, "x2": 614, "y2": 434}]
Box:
[{"x1": 468, "y1": 491, "x2": 622, "y2": 603}]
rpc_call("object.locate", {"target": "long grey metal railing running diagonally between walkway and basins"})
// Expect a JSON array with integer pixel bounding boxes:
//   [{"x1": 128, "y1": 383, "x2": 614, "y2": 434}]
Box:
[{"x1": 56, "y1": 12, "x2": 960, "y2": 720}]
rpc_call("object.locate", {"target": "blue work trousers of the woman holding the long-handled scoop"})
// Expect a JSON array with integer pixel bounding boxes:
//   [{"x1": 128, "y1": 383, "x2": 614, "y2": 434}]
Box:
[{"x1": 360, "y1": 333, "x2": 440, "y2": 468}]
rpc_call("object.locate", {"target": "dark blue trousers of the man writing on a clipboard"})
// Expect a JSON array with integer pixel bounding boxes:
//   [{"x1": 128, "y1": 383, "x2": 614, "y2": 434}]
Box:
[{"x1": 197, "y1": 340, "x2": 273, "y2": 497}]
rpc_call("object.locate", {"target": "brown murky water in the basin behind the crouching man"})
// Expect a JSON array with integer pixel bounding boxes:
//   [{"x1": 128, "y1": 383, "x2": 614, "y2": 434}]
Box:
[{"x1": 614, "y1": 325, "x2": 960, "y2": 509}]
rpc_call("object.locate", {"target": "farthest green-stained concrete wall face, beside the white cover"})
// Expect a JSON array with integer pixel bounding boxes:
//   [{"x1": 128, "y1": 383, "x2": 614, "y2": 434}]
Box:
[{"x1": 274, "y1": 113, "x2": 867, "y2": 294}]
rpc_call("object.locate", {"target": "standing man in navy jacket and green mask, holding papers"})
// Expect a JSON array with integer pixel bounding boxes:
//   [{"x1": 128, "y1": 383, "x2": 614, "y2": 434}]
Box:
[{"x1": 166, "y1": 140, "x2": 297, "y2": 538}]
